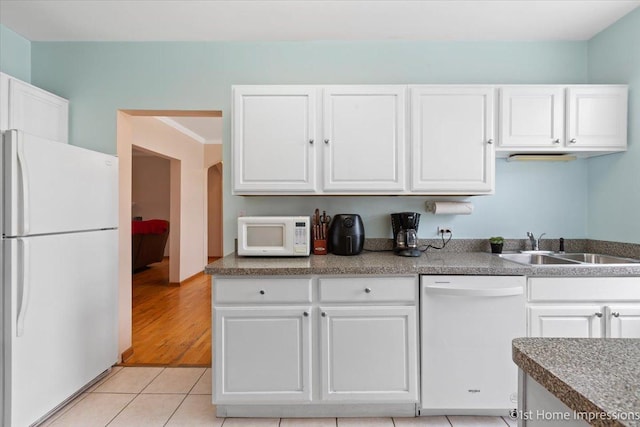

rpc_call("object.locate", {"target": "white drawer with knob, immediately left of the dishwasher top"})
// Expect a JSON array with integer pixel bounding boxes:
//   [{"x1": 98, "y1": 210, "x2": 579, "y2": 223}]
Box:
[{"x1": 320, "y1": 277, "x2": 418, "y2": 303}]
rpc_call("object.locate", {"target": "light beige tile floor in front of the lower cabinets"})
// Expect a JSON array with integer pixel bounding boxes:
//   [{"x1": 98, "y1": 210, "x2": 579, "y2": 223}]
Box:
[{"x1": 42, "y1": 366, "x2": 516, "y2": 427}]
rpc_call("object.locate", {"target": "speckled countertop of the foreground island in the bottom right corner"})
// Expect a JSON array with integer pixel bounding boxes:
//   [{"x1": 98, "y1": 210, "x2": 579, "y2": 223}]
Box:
[{"x1": 513, "y1": 338, "x2": 640, "y2": 427}]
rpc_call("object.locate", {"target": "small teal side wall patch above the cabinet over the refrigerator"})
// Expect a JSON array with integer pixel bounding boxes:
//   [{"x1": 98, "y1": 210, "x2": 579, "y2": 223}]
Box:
[{"x1": 0, "y1": 25, "x2": 31, "y2": 82}]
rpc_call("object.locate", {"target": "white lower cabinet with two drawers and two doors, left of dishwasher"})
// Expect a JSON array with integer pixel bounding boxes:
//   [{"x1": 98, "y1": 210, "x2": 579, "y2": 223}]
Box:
[{"x1": 212, "y1": 276, "x2": 419, "y2": 407}]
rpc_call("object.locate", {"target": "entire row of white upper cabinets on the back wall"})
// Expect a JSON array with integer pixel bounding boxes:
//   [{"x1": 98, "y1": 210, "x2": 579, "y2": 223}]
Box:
[{"x1": 232, "y1": 85, "x2": 627, "y2": 195}]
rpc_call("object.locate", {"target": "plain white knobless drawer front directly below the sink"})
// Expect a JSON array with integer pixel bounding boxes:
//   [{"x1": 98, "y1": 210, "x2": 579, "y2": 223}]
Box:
[{"x1": 528, "y1": 277, "x2": 640, "y2": 301}]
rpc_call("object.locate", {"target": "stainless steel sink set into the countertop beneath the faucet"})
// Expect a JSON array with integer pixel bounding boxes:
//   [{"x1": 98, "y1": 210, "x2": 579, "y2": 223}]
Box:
[{"x1": 498, "y1": 253, "x2": 640, "y2": 267}]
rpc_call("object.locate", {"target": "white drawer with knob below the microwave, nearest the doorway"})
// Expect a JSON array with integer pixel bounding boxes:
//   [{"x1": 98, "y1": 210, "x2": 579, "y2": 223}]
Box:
[{"x1": 213, "y1": 277, "x2": 312, "y2": 303}]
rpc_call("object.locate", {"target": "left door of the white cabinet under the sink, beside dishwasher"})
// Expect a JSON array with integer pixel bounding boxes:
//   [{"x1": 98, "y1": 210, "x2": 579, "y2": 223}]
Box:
[{"x1": 529, "y1": 305, "x2": 604, "y2": 338}]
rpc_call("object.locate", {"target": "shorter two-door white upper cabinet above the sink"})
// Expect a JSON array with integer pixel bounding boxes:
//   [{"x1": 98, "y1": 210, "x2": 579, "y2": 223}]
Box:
[{"x1": 497, "y1": 85, "x2": 627, "y2": 157}]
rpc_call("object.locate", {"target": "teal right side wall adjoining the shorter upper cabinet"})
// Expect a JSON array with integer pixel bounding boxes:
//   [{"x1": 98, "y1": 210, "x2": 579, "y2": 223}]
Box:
[{"x1": 588, "y1": 9, "x2": 640, "y2": 243}]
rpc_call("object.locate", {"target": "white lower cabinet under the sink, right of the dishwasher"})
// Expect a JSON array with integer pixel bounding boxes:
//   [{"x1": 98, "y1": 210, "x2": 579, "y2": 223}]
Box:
[{"x1": 527, "y1": 277, "x2": 640, "y2": 338}]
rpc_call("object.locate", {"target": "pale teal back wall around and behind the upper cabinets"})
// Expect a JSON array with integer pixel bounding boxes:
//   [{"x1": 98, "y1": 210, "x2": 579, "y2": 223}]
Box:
[{"x1": 31, "y1": 42, "x2": 587, "y2": 253}]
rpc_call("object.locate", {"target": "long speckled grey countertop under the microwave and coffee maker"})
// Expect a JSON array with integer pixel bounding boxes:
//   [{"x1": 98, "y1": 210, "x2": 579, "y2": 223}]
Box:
[{"x1": 205, "y1": 251, "x2": 640, "y2": 277}]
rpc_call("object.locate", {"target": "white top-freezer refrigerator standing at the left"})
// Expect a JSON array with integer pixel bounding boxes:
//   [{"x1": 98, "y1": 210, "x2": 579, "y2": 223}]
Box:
[{"x1": 0, "y1": 130, "x2": 118, "y2": 427}]
